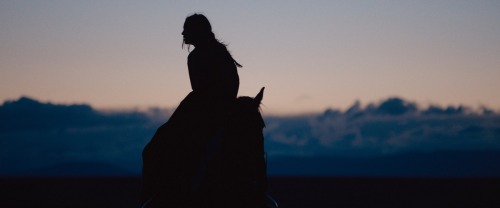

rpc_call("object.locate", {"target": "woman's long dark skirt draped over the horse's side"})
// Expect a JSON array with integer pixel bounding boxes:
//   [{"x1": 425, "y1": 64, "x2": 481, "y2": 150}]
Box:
[{"x1": 141, "y1": 92, "x2": 231, "y2": 207}]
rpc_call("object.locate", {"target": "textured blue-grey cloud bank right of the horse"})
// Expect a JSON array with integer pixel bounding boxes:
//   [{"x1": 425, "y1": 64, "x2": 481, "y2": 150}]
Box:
[{"x1": 265, "y1": 98, "x2": 500, "y2": 156}]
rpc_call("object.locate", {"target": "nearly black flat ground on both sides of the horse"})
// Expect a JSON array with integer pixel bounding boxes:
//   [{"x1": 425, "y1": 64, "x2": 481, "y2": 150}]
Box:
[{"x1": 0, "y1": 177, "x2": 500, "y2": 208}]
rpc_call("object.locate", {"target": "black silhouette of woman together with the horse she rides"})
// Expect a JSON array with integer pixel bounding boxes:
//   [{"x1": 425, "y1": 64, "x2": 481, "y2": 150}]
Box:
[{"x1": 142, "y1": 14, "x2": 274, "y2": 208}]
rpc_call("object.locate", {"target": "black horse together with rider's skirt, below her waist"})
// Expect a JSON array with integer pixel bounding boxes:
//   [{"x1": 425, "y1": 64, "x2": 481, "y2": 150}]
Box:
[{"x1": 142, "y1": 88, "x2": 276, "y2": 207}]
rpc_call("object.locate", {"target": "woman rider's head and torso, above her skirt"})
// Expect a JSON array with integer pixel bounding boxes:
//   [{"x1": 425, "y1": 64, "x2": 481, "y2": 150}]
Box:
[{"x1": 182, "y1": 14, "x2": 241, "y2": 102}]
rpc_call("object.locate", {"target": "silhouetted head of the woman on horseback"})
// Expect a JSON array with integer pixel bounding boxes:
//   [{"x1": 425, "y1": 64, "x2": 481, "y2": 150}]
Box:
[{"x1": 182, "y1": 13, "x2": 215, "y2": 46}]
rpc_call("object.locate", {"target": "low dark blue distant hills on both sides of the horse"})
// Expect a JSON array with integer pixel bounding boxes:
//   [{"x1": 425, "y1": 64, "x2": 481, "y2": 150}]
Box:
[{"x1": 4, "y1": 151, "x2": 500, "y2": 178}]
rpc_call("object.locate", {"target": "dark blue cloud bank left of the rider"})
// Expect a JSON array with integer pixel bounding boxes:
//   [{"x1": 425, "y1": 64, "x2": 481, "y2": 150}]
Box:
[{"x1": 0, "y1": 97, "x2": 164, "y2": 175}]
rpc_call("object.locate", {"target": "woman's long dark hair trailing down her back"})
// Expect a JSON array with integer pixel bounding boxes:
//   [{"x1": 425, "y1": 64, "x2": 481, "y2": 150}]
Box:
[{"x1": 182, "y1": 13, "x2": 243, "y2": 67}]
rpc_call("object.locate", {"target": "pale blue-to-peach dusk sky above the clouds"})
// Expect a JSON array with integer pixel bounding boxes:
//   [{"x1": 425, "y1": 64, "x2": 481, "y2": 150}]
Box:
[{"x1": 0, "y1": 0, "x2": 500, "y2": 113}]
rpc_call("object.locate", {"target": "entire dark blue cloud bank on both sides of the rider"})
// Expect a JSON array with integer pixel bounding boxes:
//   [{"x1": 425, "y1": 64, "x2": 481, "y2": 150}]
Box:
[{"x1": 0, "y1": 97, "x2": 500, "y2": 176}]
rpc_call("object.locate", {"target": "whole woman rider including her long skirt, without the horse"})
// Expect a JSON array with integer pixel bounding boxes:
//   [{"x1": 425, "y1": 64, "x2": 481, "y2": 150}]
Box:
[{"x1": 142, "y1": 14, "x2": 241, "y2": 207}]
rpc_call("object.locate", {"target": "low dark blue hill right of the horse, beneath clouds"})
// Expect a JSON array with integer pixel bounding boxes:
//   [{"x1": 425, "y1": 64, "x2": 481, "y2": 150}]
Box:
[{"x1": 268, "y1": 151, "x2": 500, "y2": 177}]
